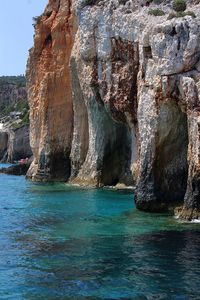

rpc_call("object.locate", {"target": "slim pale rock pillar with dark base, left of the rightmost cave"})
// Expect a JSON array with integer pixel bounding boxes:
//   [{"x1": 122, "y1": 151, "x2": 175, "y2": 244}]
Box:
[{"x1": 136, "y1": 84, "x2": 158, "y2": 211}]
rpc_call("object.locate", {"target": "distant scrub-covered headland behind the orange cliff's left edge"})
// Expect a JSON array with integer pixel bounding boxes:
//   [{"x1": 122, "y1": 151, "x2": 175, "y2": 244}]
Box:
[{"x1": 0, "y1": 76, "x2": 32, "y2": 163}]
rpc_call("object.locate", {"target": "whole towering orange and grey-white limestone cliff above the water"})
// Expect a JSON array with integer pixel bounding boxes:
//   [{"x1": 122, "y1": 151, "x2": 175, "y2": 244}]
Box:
[{"x1": 27, "y1": 0, "x2": 200, "y2": 219}]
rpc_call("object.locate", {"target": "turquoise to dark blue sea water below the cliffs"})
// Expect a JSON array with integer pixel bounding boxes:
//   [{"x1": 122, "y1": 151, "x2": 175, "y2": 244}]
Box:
[{"x1": 0, "y1": 169, "x2": 200, "y2": 300}]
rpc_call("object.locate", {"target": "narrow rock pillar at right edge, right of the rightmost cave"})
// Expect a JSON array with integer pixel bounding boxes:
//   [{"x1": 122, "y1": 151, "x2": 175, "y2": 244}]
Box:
[{"x1": 179, "y1": 76, "x2": 200, "y2": 220}]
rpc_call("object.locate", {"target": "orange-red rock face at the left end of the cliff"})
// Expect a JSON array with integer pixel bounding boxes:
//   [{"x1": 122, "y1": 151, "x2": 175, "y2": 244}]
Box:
[{"x1": 27, "y1": 0, "x2": 74, "y2": 180}]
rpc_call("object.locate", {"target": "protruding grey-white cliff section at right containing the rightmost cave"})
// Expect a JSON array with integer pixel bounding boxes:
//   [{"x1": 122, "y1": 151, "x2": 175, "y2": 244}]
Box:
[{"x1": 136, "y1": 19, "x2": 200, "y2": 219}]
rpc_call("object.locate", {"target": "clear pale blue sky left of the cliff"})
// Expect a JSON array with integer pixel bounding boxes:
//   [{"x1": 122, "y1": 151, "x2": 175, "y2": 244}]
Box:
[{"x1": 0, "y1": 0, "x2": 48, "y2": 76}]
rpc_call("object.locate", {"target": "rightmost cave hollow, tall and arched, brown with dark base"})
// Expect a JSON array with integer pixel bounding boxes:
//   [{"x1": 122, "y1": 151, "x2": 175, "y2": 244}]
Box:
[{"x1": 154, "y1": 100, "x2": 188, "y2": 204}]
